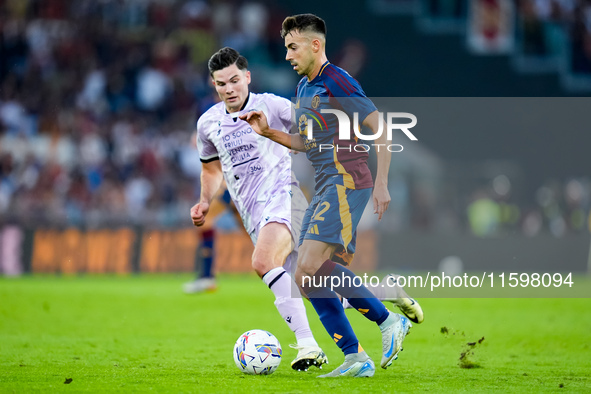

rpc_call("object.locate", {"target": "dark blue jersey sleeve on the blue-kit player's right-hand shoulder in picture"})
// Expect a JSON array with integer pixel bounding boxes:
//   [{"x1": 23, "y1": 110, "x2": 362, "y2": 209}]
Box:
[{"x1": 324, "y1": 67, "x2": 377, "y2": 122}]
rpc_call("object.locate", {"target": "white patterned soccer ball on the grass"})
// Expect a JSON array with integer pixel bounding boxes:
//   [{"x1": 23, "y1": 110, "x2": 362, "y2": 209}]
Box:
[{"x1": 234, "y1": 330, "x2": 281, "y2": 375}]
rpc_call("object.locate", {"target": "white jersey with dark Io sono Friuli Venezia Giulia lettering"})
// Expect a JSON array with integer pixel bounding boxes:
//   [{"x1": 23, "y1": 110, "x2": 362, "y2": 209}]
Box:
[{"x1": 197, "y1": 93, "x2": 307, "y2": 235}]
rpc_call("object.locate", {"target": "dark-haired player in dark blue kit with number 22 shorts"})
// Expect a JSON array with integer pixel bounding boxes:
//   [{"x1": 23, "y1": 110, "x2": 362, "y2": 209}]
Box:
[{"x1": 242, "y1": 14, "x2": 423, "y2": 377}]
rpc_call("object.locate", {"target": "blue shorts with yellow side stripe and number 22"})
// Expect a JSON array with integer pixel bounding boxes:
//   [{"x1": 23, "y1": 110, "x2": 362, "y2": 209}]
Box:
[{"x1": 299, "y1": 185, "x2": 372, "y2": 265}]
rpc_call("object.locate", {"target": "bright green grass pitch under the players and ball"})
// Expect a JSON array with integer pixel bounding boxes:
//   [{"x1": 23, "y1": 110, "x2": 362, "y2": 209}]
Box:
[{"x1": 0, "y1": 275, "x2": 591, "y2": 393}]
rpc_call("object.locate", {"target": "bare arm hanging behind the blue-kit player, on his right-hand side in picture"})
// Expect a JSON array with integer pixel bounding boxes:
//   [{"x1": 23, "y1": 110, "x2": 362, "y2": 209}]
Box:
[{"x1": 363, "y1": 111, "x2": 392, "y2": 220}]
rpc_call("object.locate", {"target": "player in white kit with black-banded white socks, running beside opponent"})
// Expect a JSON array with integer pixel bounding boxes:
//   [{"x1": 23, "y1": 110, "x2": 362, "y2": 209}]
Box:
[{"x1": 191, "y1": 47, "x2": 327, "y2": 370}]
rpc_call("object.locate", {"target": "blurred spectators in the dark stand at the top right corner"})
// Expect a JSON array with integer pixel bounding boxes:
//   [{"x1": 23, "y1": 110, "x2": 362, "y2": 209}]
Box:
[{"x1": 420, "y1": 0, "x2": 591, "y2": 72}]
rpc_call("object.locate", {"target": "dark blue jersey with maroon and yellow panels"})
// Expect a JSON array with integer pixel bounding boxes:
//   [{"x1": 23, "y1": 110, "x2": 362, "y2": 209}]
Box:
[{"x1": 295, "y1": 61, "x2": 376, "y2": 191}]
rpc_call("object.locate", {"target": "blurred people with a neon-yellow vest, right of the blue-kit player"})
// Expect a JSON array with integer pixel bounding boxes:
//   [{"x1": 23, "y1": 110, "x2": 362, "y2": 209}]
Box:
[{"x1": 420, "y1": 175, "x2": 591, "y2": 238}]
